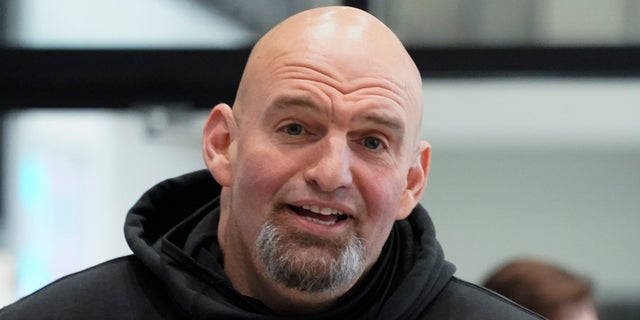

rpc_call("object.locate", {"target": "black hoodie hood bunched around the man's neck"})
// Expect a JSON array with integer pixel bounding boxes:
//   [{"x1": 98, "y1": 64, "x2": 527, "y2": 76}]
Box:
[{"x1": 125, "y1": 170, "x2": 455, "y2": 319}]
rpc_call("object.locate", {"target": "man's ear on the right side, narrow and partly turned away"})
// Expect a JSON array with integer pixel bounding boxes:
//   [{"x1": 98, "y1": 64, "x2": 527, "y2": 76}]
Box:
[{"x1": 396, "y1": 141, "x2": 431, "y2": 220}]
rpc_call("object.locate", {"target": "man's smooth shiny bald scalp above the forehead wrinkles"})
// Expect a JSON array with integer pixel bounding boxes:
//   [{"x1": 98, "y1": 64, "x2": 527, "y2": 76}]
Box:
[{"x1": 234, "y1": 7, "x2": 422, "y2": 134}]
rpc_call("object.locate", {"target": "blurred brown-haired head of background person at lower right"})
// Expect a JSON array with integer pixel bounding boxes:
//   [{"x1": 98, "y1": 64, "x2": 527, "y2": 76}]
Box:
[{"x1": 484, "y1": 259, "x2": 598, "y2": 320}]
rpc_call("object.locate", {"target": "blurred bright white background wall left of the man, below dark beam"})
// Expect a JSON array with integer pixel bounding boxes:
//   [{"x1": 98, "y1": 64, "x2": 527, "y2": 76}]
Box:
[{"x1": 0, "y1": 108, "x2": 207, "y2": 305}]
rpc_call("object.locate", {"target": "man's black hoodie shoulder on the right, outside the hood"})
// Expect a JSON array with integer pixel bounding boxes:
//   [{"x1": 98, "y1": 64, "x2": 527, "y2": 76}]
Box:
[{"x1": 428, "y1": 277, "x2": 544, "y2": 320}]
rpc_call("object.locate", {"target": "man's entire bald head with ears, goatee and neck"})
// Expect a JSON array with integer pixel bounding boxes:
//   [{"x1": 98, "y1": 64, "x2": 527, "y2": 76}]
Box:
[{"x1": 203, "y1": 7, "x2": 430, "y2": 312}]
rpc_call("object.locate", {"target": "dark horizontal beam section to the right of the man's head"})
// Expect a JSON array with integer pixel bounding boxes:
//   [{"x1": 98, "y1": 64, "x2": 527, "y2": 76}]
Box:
[{"x1": 409, "y1": 46, "x2": 640, "y2": 78}]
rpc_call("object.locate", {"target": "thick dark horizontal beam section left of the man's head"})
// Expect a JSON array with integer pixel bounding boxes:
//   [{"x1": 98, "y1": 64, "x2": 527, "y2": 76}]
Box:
[{"x1": 0, "y1": 49, "x2": 249, "y2": 109}]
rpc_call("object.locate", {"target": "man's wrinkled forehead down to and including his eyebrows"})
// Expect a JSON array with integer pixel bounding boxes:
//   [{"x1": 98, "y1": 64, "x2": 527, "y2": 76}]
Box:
[{"x1": 240, "y1": 52, "x2": 421, "y2": 142}]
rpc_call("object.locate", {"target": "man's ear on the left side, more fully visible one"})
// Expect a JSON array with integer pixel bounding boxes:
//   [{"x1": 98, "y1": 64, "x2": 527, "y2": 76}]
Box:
[{"x1": 202, "y1": 103, "x2": 237, "y2": 187}]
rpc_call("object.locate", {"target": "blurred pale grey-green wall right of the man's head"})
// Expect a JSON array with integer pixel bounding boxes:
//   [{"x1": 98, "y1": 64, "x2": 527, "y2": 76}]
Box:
[{"x1": 422, "y1": 79, "x2": 640, "y2": 302}]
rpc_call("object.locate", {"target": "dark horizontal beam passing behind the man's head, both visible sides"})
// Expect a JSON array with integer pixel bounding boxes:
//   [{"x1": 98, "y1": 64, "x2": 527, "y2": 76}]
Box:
[{"x1": 0, "y1": 47, "x2": 640, "y2": 109}]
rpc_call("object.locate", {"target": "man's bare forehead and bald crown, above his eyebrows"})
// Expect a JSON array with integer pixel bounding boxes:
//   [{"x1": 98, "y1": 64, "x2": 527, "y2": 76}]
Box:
[{"x1": 239, "y1": 10, "x2": 422, "y2": 135}]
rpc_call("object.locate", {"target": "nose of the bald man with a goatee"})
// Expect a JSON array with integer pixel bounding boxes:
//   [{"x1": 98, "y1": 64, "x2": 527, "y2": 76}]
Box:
[{"x1": 304, "y1": 137, "x2": 353, "y2": 192}]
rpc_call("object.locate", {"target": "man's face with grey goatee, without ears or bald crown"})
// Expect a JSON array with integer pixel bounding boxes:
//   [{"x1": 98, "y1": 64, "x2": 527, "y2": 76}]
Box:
[{"x1": 229, "y1": 42, "x2": 420, "y2": 292}]
